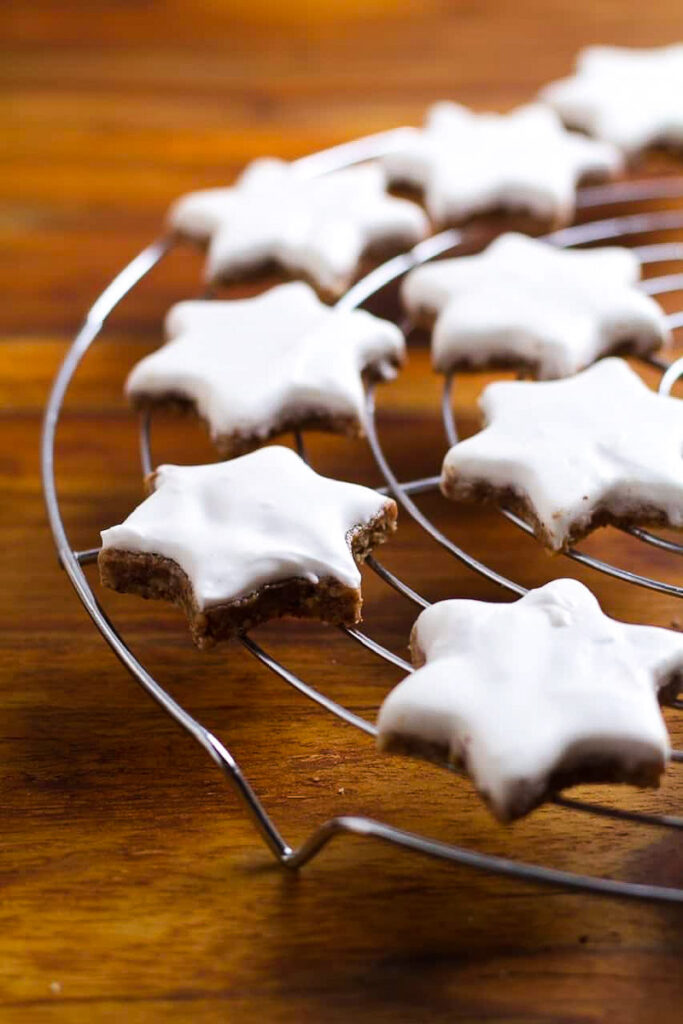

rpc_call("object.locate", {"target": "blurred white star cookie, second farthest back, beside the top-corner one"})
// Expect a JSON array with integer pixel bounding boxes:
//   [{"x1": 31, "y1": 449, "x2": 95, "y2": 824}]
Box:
[{"x1": 382, "y1": 102, "x2": 622, "y2": 225}]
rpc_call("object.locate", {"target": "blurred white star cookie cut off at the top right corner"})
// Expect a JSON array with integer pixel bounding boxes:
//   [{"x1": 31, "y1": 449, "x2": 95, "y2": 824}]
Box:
[{"x1": 540, "y1": 43, "x2": 683, "y2": 157}]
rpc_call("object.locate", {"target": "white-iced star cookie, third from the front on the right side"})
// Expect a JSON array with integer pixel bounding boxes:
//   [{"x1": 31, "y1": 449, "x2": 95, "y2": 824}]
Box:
[{"x1": 401, "y1": 233, "x2": 670, "y2": 380}]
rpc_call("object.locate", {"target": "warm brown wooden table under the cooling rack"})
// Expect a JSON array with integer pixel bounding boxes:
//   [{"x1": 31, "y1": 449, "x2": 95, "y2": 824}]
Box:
[{"x1": 0, "y1": 0, "x2": 683, "y2": 1024}]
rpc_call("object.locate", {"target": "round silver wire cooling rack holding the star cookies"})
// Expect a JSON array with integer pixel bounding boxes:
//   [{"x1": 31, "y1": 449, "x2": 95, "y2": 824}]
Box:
[{"x1": 41, "y1": 129, "x2": 683, "y2": 903}]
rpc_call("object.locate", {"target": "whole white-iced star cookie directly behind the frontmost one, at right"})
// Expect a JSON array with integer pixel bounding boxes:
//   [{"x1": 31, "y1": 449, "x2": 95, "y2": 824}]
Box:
[{"x1": 441, "y1": 358, "x2": 683, "y2": 551}]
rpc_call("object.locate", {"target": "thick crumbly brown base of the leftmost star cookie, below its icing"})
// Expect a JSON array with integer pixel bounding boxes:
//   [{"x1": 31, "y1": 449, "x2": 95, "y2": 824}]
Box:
[{"x1": 97, "y1": 499, "x2": 396, "y2": 649}]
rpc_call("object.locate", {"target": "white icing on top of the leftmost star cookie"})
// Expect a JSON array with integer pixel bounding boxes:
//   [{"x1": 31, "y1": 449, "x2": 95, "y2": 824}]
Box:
[{"x1": 101, "y1": 446, "x2": 389, "y2": 609}]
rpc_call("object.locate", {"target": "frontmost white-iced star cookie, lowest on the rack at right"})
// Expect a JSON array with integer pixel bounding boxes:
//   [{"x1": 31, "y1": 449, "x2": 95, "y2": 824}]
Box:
[{"x1": 378, "y1": 580, "x2": 683, "y2": 821}]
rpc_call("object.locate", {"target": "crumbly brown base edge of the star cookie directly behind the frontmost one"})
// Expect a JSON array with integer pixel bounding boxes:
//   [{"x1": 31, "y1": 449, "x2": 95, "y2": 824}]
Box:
[{"x1": 441, "y1": 471, "x2": 678, "y2": 553}]
